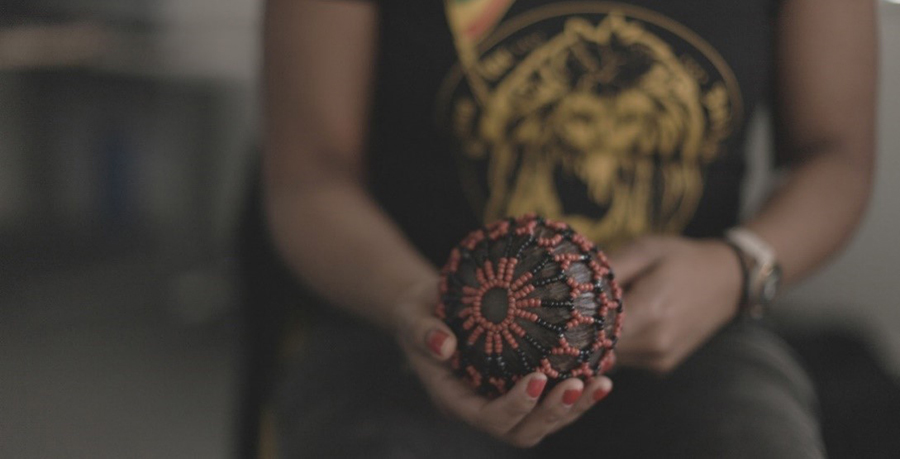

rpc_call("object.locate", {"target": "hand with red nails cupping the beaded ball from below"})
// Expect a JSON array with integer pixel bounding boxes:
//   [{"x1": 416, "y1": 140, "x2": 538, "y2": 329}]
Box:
[{"x1": 395, "y1": 281, "x2": 612, "y2": 447}]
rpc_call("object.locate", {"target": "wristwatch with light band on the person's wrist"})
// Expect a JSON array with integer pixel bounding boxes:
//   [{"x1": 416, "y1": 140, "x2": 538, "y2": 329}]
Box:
[{"x1": 725, "y1": 227, "x2": 781, "y2": 318}]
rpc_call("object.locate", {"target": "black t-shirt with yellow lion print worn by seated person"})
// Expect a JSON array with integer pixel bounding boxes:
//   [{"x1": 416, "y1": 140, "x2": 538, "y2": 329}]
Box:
[{"x1": 367, "y1": 0, "x2": 776, "y2": 264}]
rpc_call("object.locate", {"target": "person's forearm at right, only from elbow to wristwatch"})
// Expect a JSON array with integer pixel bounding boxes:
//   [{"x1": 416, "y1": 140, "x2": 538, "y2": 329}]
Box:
[{"x1": 746, "y1": 144, "x2": 872, "y2": 283}]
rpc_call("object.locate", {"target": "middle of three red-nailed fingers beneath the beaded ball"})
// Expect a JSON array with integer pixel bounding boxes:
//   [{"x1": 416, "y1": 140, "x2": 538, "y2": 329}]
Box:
[{"x1": 508, "y1": 378, "x2": 584, "y2": 447}]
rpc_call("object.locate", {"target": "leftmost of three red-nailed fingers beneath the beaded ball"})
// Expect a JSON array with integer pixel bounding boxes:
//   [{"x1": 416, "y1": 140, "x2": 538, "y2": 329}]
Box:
[{"x1": 476, "y1": 373, "x2": 547, "y2": 436}]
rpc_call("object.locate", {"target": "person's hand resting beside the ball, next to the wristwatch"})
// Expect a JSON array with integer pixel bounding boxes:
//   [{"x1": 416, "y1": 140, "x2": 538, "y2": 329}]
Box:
[{"x1": 609, "y1": 237, "x2": 743, "y2": 373}]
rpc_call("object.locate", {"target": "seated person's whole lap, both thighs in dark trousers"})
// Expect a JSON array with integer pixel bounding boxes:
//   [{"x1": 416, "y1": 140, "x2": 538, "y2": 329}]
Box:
[{"x1": 274, "y1": 316, "x2": 824, "y2": 458}]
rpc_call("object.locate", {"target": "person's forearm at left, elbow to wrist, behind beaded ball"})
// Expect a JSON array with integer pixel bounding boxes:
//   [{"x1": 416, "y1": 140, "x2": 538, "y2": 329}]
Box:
[{"x1": 266, "y1": 179, "x2": 437, "y2": 329}]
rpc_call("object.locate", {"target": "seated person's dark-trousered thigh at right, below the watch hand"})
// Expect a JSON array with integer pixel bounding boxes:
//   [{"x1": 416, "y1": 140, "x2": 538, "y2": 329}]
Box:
[{"x1": 541, "y1": 322, "x2": 825, "y2": 458}]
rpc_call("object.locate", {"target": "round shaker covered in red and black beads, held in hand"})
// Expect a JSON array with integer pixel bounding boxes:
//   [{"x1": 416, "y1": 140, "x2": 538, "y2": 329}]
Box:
[{"x1": 435, "y1": 215, "x2": 623, "y2": 397}]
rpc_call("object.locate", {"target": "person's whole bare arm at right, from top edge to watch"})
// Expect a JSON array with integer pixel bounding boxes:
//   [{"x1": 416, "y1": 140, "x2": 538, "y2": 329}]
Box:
[{"x1": 747, "y1": 0, "x2": 878, "y2": 283}]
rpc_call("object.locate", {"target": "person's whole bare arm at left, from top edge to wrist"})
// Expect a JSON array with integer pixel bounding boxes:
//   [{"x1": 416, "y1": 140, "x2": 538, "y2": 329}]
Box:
[{"x1": 263, "y1": 0, "x2": 437, "y2": 327}]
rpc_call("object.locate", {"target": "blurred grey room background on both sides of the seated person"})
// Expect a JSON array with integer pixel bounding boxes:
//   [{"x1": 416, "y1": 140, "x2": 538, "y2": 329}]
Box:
[{"x1": 0, "y1": 0, "x2": 900, "y2": 458}]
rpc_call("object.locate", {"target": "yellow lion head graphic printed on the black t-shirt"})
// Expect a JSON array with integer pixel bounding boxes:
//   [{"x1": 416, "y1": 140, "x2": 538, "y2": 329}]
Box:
[{"x1": 436, "y1": 4, "x2": 739, "y2": 250}]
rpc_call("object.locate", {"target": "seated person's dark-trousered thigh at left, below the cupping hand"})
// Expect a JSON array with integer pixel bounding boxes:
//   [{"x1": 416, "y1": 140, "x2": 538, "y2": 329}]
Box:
[{"x1": 274, "y1": 323, "x2": 522, "y2": 459}]
